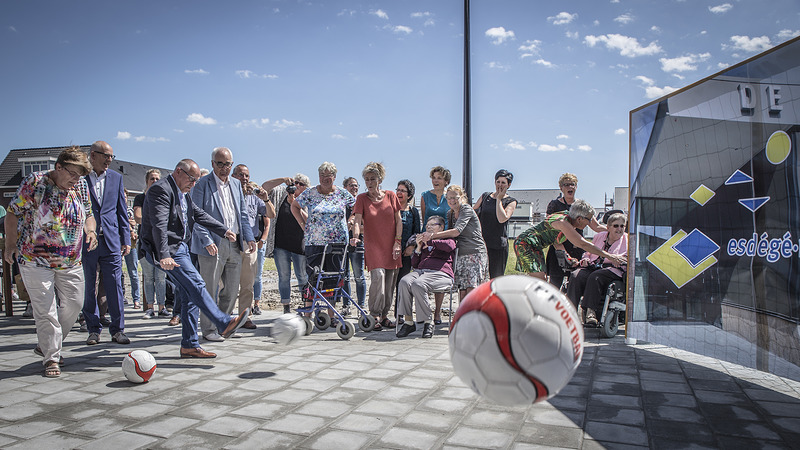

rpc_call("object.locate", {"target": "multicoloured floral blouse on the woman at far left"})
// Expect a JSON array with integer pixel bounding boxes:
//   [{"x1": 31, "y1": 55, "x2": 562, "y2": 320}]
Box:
[{"x1": 8, "y1": 171, "x2": 92, "y2": 269}]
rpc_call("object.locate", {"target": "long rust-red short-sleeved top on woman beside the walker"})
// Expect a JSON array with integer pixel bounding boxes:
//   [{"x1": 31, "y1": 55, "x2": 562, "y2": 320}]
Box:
[{"x1": 353, "y1": 191, "x2": 403, "y2": 270}]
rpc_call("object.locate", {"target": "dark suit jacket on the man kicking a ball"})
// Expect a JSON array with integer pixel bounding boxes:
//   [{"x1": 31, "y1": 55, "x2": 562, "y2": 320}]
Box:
[{"x1": 139, "y1": 175, "x2": 228, "y2": 262}]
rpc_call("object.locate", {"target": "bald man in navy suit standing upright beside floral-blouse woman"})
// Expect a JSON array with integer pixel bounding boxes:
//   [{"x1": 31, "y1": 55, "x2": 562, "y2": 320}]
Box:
[{"x1": 83, "y1": 141, "x2": 131, "y2": 345}]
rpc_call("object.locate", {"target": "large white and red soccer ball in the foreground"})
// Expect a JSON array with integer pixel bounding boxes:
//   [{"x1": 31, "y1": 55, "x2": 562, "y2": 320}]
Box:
[{"x1": 450, "y1": 275, "x2": 583, "y2": 405}]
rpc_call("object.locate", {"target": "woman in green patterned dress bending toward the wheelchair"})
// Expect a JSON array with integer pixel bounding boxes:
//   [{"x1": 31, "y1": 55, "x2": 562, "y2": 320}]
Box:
[{"x1": 514, "y1": 199, "x2": 628, "y2": 280}]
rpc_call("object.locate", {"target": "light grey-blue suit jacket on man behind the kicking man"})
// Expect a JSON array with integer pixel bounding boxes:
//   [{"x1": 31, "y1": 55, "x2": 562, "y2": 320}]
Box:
[{"x1": 190, "y1": 172, "x2": 255, "y2": 256}]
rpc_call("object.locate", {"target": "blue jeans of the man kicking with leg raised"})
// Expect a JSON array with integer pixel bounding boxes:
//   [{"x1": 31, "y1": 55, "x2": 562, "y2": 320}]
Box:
[{"x1": 147, "y1": 243, "x2": 232, "y2": 348}]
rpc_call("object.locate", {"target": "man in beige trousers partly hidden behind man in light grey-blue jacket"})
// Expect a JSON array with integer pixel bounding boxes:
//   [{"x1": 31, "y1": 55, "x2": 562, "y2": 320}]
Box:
[{"x1": 232, "y1": 164, "x2": 275, "y2": 322}]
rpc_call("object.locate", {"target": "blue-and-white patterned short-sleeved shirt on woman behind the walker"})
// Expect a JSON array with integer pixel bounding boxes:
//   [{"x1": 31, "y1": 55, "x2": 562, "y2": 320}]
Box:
[{"x1": 294, "y1": 186, "x2": 356, "y2": 246}]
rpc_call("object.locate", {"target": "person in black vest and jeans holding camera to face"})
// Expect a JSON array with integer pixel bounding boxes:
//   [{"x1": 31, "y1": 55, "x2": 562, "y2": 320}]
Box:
[{"x1": 261, "y1": 173, "x2": 311, "y2": 313}]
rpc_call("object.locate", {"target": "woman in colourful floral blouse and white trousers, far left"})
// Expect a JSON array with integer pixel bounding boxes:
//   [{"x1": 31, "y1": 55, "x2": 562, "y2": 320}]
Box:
[{"x1": 3, "y1": 147, "x2": 97, "y2": 377}]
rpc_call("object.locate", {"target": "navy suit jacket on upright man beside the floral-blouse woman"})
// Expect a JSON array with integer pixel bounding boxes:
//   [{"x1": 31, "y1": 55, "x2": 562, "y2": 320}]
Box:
[{"x1": 84, "y1": 169, "x2": 131, "y2": 253}]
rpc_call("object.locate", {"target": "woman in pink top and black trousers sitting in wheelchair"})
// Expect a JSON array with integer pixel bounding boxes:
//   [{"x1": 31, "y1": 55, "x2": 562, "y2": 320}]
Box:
[{"x1": 567, "y1": 213, "x2": 628, "y2": 326}]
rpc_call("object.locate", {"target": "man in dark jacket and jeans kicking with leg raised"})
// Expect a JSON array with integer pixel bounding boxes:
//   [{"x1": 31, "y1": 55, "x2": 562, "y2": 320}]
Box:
[{"x1": 139, "y1": 159, "x2": 250, "y2": 358}]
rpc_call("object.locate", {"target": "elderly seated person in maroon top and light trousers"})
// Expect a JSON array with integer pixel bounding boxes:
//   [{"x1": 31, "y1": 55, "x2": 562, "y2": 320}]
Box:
[{"x1": 397, "y1": 216, "x2": 456, "y2": 338}]
